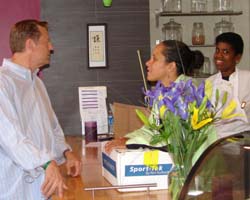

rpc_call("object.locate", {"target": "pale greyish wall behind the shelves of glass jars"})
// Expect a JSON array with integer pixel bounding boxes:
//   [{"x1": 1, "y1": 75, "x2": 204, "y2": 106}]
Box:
[{"x1": 149, "y1": 0, "x2": 250, "y2": 70}]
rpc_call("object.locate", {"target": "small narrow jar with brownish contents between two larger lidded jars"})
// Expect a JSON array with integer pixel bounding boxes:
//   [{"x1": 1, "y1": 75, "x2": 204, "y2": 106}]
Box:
[{"x1": 192, "y1": 22, "x2": 205, "y2": 45}]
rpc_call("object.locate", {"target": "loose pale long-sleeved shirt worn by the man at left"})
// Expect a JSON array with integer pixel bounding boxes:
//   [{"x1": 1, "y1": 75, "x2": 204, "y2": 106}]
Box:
[{"x1": 0, "y1": 59, "x2": 70, "y2": 200}]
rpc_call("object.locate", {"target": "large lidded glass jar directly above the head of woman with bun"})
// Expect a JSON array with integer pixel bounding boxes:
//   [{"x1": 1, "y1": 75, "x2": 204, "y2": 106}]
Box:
[{"x1": 162, "y1": 18, "x2": 182, "y2": 41}]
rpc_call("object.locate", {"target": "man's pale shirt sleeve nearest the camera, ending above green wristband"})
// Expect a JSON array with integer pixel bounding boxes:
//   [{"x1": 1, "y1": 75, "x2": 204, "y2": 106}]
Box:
[{"x1": 0, "y1": 87, "x2": 52, "y2": 170}]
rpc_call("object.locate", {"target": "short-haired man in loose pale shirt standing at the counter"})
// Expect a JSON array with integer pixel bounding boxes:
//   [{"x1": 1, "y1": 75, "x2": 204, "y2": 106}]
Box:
[{"x1": 0, "y1": 20, "x2": 81, "y2": 200}]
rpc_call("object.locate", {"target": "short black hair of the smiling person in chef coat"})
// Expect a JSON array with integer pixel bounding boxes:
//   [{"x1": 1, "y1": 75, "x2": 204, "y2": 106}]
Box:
[{"x1": 215, "y1": 32, "x2": 244, "y2": 55}]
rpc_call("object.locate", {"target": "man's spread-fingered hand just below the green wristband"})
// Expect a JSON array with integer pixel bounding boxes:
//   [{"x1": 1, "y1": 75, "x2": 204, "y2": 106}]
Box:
[{"x1": 41, "y1": 160, "x2": 68, "y2": 198}]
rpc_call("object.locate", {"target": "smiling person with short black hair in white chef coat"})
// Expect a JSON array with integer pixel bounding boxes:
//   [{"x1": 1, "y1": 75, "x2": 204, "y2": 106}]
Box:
[{"x1": 208, "y1": 32, "x2": 250, "y2": 137}]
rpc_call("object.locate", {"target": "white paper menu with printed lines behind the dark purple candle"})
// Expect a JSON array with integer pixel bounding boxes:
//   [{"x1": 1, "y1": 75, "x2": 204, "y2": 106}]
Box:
[{"x1": 78, "y1": 86, "x2": 108, "y2": 135}]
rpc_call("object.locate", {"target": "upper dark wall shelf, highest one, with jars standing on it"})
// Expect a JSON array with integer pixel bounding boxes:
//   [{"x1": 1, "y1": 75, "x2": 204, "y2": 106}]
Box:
[{"x1": 159, "y1": 11, "x2": 242, "y2": 17}]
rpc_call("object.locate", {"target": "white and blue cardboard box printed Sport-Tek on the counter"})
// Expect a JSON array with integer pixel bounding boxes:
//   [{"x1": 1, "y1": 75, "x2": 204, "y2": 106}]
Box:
[{"x1": 102, "y1": 143, "x2": 173, "y2": 192}]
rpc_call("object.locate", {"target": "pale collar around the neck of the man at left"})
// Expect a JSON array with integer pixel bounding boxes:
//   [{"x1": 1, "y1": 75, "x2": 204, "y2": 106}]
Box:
[{"x1": 2, "y1": 58, "x2": 38, "y2": 80}]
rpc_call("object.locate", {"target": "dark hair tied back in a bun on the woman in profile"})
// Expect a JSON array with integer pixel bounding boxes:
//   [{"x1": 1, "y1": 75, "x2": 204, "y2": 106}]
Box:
[{"x1": 162, "y1": 40, "x2": 204, "y2": 75}]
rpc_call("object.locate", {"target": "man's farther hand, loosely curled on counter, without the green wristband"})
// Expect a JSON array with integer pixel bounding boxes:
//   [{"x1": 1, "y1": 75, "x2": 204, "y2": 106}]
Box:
[{"x1": 64, "y1": 150, "x2": 81, "y2": 177}]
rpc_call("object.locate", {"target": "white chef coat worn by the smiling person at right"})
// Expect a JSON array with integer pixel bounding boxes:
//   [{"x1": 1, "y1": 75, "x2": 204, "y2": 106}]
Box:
[{"x1": 207, "y1": 68, "x2": 250, "y2": 138}]
